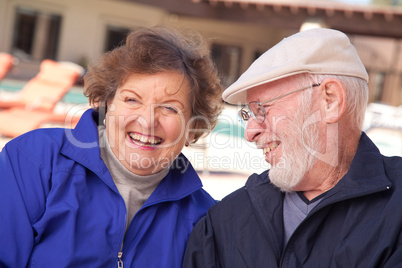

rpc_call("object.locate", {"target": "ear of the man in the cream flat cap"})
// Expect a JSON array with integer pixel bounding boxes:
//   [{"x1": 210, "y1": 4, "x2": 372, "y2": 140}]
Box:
[{"x1": 321, "y1": 78, "x2": 347, "y2": 124}]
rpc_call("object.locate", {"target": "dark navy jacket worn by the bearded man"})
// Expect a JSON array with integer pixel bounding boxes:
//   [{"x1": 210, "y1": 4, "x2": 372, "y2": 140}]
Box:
[{"x1": 184, "y1": 133, "x2": 402, "y2": 268}]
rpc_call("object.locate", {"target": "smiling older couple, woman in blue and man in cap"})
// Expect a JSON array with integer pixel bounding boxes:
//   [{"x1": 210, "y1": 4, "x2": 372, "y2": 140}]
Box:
[{"x1": 0, "y1": 27, "x2": 402, "y2": 268}]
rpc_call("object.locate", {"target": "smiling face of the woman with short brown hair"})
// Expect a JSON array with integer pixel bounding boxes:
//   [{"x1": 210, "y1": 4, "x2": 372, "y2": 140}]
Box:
[{"x1": 105, "y1": 72, "x2": 192, "y2": 175}]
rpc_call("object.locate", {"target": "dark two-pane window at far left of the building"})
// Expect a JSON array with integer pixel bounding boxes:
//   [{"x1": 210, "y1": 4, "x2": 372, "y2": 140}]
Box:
[{"x1": 12, "y1": 7, "x2": 61, "y2": 60}]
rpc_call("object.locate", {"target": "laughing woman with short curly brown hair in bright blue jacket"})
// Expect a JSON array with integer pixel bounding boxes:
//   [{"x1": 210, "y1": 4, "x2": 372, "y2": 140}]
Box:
[{"x1": 0, "y1": 27, "x2": 222, "y2": 268}]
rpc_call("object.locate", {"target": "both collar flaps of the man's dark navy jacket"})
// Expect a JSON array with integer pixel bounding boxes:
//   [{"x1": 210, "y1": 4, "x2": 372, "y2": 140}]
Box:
[{"x1": 246, "y1": 133, "x2": 391, "y2": 259}]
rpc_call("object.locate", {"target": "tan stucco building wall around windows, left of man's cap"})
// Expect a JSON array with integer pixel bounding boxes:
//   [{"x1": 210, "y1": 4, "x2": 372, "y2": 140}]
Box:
[{"x1": 0, "y1": 0, "x2": 287, "y2": 71}]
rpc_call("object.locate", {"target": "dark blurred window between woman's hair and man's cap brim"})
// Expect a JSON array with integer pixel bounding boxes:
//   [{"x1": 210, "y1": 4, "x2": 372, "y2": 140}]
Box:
[{"x1": 211, "y1": 44, "x2": 242, "y2": 86}]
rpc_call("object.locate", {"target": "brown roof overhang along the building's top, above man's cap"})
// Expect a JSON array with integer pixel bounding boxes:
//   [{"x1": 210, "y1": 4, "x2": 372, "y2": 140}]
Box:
[{"x1": 126, "y1": 0, "x2": 402, "y2": 38}]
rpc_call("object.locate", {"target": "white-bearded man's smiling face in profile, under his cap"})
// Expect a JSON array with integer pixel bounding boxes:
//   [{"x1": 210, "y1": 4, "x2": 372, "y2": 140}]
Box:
[{"x1": 245, "y1": 77, "x2": 326, "y2": 191}]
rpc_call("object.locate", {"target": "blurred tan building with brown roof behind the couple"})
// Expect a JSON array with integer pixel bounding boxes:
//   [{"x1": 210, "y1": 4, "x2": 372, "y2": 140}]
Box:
[{"x1": 0, "y1": 0, "x2": 402, "y2": 106}]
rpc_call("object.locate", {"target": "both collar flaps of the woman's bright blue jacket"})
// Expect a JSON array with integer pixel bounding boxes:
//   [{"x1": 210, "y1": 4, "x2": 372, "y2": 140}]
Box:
[{"x1": 61, "y1": 109, "x2": 202, "y2": 201}]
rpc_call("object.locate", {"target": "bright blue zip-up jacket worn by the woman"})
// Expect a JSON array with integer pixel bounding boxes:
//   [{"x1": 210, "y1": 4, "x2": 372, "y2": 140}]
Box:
[{"x1": 0, "y1": 110, "x2": 215, "y2": 268}]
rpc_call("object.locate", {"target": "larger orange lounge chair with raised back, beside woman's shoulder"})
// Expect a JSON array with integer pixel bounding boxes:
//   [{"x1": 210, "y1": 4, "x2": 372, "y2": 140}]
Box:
[{"x1": 0, "y1": 60, "x2": 83, "y2": 138}]
